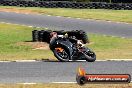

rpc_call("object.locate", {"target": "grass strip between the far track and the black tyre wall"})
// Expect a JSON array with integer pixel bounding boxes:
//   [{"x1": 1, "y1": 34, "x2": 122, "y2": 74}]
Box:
[{"x1": 0, "y1": 6, "x2": 132, "y2": 23}]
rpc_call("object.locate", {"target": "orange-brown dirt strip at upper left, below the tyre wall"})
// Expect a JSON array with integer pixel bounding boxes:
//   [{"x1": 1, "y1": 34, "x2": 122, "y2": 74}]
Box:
[{"x1": 0, "y1": 8, "x2": 38, "y2": 14}]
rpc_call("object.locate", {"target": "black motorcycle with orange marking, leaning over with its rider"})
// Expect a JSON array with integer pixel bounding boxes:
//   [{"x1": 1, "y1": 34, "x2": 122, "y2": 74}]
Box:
[{"x1": 49, "y1": 32, "x2": 96, "y2": 62}]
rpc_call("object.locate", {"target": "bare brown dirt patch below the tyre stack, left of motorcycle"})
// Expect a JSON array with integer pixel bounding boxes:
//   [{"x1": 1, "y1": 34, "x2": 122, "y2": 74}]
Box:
[{"x1": 16, "y1": 42, "x2": 49, "y2": 50}]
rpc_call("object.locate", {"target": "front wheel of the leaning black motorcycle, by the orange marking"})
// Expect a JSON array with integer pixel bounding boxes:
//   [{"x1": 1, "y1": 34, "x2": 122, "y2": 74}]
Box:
[{"x1": 53, "y1": 47, "x2": 69, "y2": 62}]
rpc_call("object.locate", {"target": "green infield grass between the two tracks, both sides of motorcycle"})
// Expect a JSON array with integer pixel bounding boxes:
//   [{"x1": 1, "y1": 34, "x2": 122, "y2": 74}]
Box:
[{"x1": 0, "y1": 23, "x2": 132, "y2": 60}]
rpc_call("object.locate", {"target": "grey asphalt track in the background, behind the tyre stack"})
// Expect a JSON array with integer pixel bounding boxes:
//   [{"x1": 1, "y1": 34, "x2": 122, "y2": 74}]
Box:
[{"x1": 0, "y1": 12, "x2": 132, "y2": 38}]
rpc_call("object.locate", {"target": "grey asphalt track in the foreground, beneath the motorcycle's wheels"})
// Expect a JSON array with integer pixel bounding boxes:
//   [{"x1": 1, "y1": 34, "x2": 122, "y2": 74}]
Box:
[{"x1": 0, "y1": 61, "x2": 132, "y2": 83}]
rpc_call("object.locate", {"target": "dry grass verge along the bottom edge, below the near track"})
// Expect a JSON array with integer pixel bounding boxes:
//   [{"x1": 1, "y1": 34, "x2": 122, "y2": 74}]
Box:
[{"x1": 0, "y1": 83, "x2": 132, "y2": 88}]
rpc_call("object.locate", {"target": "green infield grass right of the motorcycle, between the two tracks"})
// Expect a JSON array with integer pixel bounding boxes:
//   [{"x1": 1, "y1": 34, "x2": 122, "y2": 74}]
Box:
[{"x1": 89, "y1": 34, "x2": 132, "y2": 59}]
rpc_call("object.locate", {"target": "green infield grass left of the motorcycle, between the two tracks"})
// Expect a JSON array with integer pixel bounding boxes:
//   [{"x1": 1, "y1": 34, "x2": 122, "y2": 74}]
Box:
[{"x1": 0, "y1": 24, "x2": 53, "y2": 60}]
